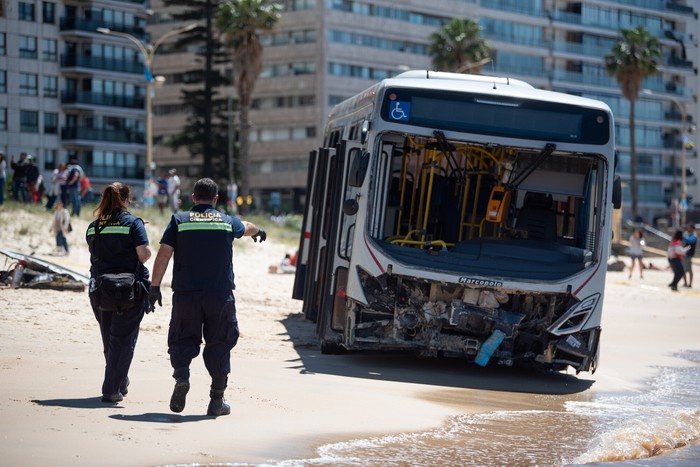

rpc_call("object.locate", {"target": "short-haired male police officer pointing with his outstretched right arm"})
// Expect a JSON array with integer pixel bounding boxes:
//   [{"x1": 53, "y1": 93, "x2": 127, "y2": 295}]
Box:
[{"x1": 149, "y1": 178, "x2": 267, "y2": 417}]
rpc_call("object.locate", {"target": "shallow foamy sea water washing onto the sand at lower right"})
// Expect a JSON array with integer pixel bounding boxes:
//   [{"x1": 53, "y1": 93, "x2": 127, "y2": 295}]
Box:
[{"x1": 193, "y1": 352, "x2": 700, "y2": 467}]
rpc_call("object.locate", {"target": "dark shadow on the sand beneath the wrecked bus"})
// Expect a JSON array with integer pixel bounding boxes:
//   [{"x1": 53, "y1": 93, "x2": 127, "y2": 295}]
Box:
[{"x1": 281, "y1": 314, "x2": 594, "y2": 394}]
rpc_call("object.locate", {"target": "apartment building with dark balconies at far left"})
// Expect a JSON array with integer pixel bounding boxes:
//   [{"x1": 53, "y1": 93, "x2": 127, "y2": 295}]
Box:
[{"x1": 0, "y1": 0, "x2": 149, "y2": 197}]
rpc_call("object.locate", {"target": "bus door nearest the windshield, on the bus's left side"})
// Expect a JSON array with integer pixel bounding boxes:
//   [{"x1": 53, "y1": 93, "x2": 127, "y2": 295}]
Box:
[{"x1": 316, "y1": 140, "x2": 369, "y2": 353}]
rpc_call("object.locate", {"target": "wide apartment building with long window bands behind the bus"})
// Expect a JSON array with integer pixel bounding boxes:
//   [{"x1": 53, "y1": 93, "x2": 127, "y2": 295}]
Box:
[{"x1": 237, "y1": 0, "x2": 700, "y2": 220}]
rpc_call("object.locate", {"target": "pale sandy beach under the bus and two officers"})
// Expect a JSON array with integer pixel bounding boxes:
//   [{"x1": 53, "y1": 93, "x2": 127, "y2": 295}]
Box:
[{"x1": 0, "y1": 211, "x2": 700, "y2": 466}]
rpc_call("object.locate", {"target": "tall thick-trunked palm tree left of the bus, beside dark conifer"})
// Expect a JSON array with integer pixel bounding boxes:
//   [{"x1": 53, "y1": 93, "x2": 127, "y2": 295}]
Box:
[{"x1": 214, "y1": 0, "x2": 282, "y2": 211}]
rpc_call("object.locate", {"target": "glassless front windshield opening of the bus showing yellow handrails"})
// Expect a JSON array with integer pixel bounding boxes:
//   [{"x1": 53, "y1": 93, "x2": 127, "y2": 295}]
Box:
[{"x1": 369, "y1": 132, "x2": 605, "y2": 280}]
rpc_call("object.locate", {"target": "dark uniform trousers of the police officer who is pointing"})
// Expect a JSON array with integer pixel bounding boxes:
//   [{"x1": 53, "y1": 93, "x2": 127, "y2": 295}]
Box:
[{"x1": 168, "y1": 291, "x2": 239, "y2": 379}]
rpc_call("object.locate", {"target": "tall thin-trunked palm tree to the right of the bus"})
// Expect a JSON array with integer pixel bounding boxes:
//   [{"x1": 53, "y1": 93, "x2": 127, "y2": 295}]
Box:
[{"x1": 605, "y1": 26, "x2": 661, "y2": 218}]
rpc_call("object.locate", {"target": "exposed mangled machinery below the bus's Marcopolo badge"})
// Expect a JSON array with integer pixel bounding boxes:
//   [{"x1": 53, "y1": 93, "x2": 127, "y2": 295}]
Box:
[{"x1": 347, "y1": 272, "x2": 599, "y2": 371}]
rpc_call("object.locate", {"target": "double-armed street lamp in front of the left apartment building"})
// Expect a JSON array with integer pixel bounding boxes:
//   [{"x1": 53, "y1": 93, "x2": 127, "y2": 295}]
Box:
[{"x1": 97, "y1": 23, "x2": 199, "y2": 199}]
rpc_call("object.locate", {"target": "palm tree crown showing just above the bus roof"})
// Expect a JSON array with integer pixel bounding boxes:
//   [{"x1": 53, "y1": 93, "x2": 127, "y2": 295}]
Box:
[{"x1": 428, "y1": 18, "x2": 491, "y2": 74}]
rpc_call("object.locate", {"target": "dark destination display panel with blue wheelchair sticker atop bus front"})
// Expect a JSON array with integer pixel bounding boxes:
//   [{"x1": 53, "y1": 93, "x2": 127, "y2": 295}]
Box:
[{"x1": 381, "y1": 88, "x2": 610, "y2": 145}]
